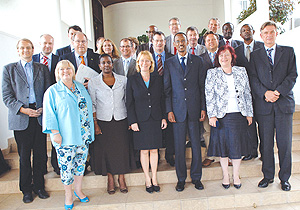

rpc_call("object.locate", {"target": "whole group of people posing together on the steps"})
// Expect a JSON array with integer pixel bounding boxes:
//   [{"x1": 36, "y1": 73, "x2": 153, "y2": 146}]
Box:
[{"x1": 2, "y1": 14, "x2": 297, "y2": 209}]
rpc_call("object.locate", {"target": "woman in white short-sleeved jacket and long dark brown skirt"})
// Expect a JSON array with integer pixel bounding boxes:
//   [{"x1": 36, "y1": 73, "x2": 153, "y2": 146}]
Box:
[{"x1": 88, "y1": 54, "x2": 134, "y2": 194}]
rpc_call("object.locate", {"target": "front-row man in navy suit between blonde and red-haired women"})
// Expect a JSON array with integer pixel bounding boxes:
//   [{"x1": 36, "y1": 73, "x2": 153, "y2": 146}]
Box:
[{"x1": 164, "y1": 32, "x2": 206, "y2": 191}]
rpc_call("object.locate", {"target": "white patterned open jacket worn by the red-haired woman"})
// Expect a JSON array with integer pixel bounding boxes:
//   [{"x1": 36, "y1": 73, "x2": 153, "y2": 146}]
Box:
[{"x1": 205, "y1": 66, "x2": 253, "y2": 118}]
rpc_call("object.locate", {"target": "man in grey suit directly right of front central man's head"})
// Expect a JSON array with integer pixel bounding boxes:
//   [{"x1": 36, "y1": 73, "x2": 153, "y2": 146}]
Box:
[{"x1": 186, "y1": 26, "x2": 205, "y2": 55}]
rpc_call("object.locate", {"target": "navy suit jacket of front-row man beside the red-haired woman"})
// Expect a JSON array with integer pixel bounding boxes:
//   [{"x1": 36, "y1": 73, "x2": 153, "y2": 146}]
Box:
[{"x1": 164, "y1": 54, "x2": 205, "y2": 122}]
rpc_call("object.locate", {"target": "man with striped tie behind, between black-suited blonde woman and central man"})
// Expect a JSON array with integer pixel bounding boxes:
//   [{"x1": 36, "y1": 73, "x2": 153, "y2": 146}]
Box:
[{"x1": 152, "y1": 31, "x2": 175, "y2": 166}]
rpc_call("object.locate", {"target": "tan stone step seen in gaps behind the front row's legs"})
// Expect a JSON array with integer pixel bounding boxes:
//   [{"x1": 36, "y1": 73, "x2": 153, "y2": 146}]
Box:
[{"x1": 0, "y1": 151, "x2": 300, "y2": 195}]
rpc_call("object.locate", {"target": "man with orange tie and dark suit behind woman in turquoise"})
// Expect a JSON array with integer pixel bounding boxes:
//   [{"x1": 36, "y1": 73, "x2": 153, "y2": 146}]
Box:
[{"x1": 60, "y1": 32, "x2": 101, "y2": 88}]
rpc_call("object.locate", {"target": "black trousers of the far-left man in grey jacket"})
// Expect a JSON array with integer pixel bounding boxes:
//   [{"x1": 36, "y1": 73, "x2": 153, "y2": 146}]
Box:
[{"x1": 14, "y1": 117, "x2": 47, "y2": 193}]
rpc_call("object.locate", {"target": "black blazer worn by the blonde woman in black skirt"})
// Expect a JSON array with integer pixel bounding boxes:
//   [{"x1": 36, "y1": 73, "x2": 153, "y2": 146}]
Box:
[{"x1": 126, "y1": 73, "x2": 166, "y2": 125}]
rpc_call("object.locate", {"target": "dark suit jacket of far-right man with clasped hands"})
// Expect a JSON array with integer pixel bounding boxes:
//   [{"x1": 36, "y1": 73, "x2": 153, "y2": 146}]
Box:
[{"x1": 250, "y1": 45, "x2": 298, "y2": 115}]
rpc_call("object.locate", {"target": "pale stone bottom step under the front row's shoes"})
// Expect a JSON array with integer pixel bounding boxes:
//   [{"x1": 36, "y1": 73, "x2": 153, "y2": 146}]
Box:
[{"x1": 0, "y1": 175, "x2": 300, "y2": 210}]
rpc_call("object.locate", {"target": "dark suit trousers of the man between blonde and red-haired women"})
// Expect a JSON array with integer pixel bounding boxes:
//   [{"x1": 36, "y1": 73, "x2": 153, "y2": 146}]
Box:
[{"x1": 173, "y1": 115, "x2": 202, "y2": 181}]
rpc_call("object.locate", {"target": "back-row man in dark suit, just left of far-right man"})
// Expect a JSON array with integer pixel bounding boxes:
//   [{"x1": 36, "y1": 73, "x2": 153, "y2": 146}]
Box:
[{"x1": 235, "y1": 24, "x2": 264, "y2": 160}]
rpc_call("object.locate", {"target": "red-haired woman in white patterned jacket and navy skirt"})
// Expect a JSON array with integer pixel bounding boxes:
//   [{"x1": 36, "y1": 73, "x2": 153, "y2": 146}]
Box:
[{"x1": 205, "y1": 45, "x2": 253, "y2": 189}]
